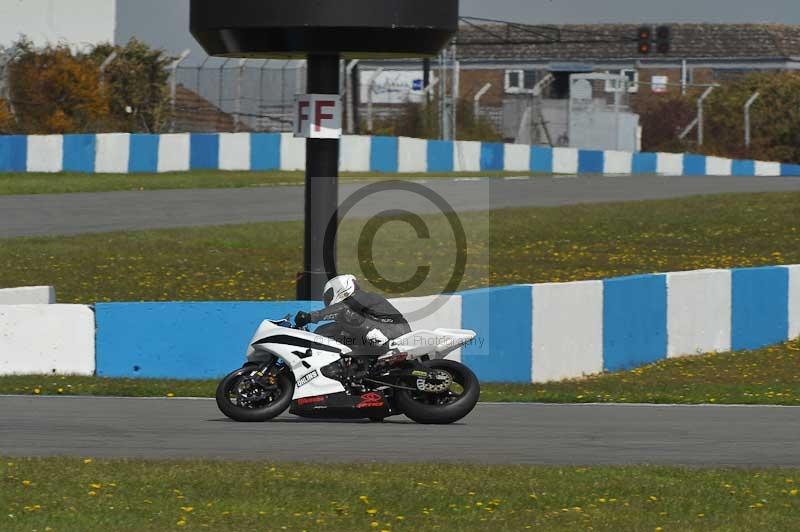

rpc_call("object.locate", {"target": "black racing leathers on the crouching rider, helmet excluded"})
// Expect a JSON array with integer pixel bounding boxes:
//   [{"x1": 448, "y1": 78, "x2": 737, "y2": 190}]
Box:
[{"x1": 309, "y1": 290, "x2": 411, "y2": 347}]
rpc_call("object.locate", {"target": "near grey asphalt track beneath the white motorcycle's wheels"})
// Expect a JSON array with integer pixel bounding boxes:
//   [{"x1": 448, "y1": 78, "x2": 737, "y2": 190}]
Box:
[{"x1": 0, "y1": 396, "x2": 800, "y2": 467}]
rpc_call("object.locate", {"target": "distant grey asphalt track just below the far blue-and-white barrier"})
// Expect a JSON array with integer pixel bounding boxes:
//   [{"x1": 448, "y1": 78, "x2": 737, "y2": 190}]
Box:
[{"x1": 0, "y1": 176, "x2": 800, "y2": 238}]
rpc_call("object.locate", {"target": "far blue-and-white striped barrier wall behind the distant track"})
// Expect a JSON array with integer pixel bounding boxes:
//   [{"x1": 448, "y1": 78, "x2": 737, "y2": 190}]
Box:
[{"x1": 0, "y1": 133, "x2": 800, "y2": 177}]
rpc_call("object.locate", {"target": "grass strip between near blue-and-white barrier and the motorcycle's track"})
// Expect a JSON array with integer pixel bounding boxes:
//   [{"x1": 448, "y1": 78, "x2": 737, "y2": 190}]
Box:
[{"x1": 0, "y1": 340, "x2": 800, "y2": 405}]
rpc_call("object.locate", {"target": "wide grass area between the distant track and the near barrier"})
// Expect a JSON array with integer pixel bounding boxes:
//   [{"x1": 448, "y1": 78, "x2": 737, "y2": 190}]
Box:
[{"x1": 0, "y1": 193, "x2": 800, "y2": 304}]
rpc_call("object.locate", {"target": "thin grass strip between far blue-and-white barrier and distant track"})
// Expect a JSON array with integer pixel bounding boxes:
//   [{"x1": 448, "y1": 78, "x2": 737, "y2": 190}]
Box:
[{"x1": 0, "y1": 170, "x2": 531, "y2": 196}]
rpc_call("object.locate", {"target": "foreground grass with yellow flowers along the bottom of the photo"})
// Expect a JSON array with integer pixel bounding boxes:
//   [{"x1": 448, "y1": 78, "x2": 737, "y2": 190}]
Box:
[{"x1": 0, "y1": 458, "x2": 800, "y2": 532}]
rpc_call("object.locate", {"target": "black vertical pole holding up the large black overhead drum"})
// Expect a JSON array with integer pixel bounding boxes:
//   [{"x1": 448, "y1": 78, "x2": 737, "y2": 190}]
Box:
[{"x1": 297, "y1": 54, "x2": 339, "y2": 301}]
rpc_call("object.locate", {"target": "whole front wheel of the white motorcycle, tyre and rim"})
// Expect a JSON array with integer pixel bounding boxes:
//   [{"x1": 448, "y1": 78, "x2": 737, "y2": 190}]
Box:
[{"x1": 216, "y1": 365, "x2": 294, "y2": 422}]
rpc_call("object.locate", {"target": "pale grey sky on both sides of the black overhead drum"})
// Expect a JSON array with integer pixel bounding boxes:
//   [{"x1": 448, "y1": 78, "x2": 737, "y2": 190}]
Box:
[{"x1": 117, "y1": 0, "x2": 800, "y2": 63}]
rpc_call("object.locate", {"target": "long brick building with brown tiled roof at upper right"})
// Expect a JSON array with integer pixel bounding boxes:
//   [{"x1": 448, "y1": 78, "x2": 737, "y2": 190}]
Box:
[{"x1": 457, "y1": 24, "x2": 800, "y2": 106}]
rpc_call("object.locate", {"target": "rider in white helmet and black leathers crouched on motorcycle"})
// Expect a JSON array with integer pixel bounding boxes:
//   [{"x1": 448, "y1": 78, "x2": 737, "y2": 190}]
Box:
[{"x1": 295, "y1": 275, "x2": 411, "y2": 348}]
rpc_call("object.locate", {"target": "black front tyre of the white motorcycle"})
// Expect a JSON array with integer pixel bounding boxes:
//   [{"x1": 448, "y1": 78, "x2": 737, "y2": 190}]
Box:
[{"x1": 216, "y1": 366, "x2": 294, "y2": 423}]
